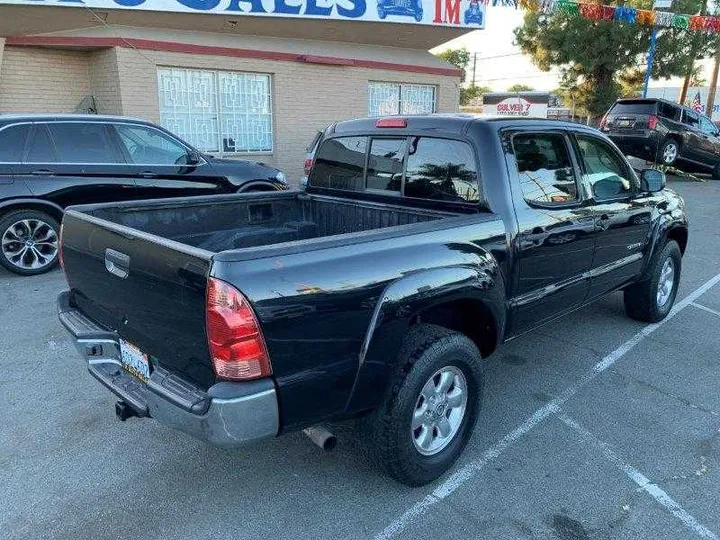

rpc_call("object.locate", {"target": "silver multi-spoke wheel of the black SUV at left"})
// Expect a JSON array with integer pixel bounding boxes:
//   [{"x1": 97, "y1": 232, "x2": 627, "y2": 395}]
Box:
[{"x1": 0, "y1": 210, "x2": 60, "y2": 276}]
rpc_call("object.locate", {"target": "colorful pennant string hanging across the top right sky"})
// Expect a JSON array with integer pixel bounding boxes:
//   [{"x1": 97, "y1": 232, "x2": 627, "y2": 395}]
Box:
[{"x1": 492, "y1": 0, "x2": 720, "y2": 32}]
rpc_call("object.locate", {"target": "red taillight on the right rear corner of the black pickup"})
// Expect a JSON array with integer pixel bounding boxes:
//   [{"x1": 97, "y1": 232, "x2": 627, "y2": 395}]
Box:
[{"x1": 205, "y1": 277, "x2": 272, "y2": 381}]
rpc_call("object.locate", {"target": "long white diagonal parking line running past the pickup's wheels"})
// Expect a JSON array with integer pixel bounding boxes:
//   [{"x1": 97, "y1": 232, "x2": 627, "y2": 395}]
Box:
[{"x1": 375, "y1": 274, "x2": 720, "y2": 540}]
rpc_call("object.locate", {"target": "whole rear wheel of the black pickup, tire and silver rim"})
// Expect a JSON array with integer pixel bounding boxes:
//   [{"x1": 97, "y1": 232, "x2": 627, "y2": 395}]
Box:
[{"x1": 372, "y1": 324, "x2": 483, "y2": 486}]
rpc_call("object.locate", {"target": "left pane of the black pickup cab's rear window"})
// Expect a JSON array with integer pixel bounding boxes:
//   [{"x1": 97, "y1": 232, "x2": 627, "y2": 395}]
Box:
[{"x1": 309, "y1": 137, "x2": 367, "y2": 191}]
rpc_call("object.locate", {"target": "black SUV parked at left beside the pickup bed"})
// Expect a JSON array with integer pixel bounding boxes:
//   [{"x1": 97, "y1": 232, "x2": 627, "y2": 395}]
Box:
[{"x1": 0, "y1": 115, "x2": 287, "y2": 274}]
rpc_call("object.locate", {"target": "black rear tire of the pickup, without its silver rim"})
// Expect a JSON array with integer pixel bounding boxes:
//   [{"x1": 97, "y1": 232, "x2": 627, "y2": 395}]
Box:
[{"x1": 370, "y1": 324, "x2": 484, "y2": 486}]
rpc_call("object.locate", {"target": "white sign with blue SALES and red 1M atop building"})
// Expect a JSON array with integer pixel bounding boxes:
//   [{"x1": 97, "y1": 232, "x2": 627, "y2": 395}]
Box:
[{"x1": 0, "y1": 0, "x2": 485, "y2": 29}]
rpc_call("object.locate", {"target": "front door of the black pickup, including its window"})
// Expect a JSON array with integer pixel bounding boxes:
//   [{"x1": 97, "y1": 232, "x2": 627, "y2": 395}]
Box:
[{"x1": 575, "y1": 133, "x2": 653, "y2": 298}]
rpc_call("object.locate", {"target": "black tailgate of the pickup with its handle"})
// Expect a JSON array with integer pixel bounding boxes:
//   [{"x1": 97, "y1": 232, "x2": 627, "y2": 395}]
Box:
[{"x1": 62, "y1": 209, "x2": 215, "y2": 389}]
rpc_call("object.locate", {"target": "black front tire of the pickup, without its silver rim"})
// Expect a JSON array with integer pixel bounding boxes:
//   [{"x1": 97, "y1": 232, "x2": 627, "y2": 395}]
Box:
[{"x1": 624, "y1": 240, "x2": 682, "y2": 322}]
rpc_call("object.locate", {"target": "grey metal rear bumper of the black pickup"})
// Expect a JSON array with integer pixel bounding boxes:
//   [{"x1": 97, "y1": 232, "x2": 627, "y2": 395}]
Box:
[{"x1": 58, "y1": 292, "x2": 279, "y2": 447}]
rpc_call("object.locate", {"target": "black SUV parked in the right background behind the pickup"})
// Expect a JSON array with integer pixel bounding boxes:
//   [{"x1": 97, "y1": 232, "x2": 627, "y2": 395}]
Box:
[{"x1": 600, "y1": 98, "x2": 720, "y2": 178}]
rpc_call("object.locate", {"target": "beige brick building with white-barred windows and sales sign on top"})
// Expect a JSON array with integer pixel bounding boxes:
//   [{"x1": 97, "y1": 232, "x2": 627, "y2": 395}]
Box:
[{"x1": 0, "y1": 0, "x2": 484, "y2": 182}]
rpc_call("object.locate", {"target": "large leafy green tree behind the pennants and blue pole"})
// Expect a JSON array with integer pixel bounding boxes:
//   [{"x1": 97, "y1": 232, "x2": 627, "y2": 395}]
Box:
[{"x1": 515, "y1": 0, "x2": 713, "y2": 118}]
